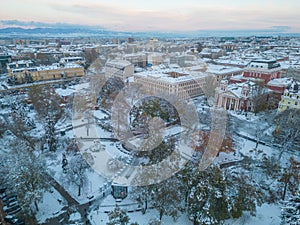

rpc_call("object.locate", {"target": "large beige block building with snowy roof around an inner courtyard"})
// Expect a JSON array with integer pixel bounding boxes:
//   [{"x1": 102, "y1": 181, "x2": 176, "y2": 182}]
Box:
[{"x1": 134, "y1": 69, "x2": 207, "y2": 99}]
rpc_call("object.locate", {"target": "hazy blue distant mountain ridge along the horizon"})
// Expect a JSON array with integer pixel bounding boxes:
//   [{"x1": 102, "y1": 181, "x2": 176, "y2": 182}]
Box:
[{"x1": 0, "y1": 26, "x2": 300, "y2": 38}]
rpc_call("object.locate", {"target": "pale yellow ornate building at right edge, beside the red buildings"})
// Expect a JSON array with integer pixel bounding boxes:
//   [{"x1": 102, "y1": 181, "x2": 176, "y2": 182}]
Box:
[{"x1": 278, "y1": 80, "x2": 300, "y2": 112}]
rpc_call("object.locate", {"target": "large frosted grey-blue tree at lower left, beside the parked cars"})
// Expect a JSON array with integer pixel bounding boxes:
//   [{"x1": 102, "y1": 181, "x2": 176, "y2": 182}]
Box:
[{"x1": 1, "y1": 142, "x2": 49, "y2": 213}]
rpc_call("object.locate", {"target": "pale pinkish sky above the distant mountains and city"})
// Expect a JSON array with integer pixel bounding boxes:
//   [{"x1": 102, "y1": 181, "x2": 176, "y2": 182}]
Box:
[{"x1": 0, "y1": 0, "x2": 300, "y2": 32}]
